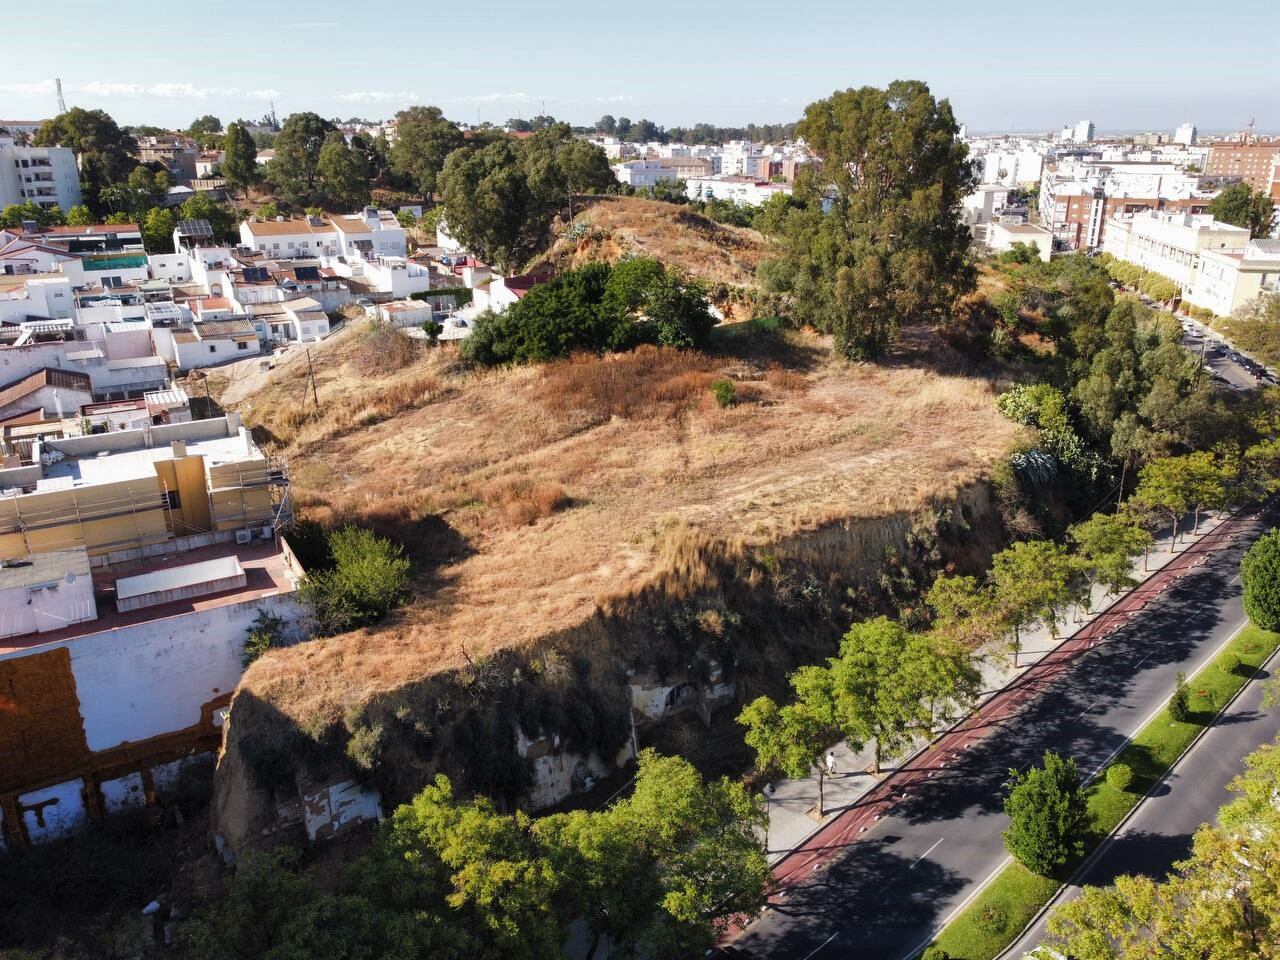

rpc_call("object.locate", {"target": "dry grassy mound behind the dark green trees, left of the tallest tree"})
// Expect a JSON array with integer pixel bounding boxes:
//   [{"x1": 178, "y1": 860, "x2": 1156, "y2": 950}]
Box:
[{"x1": 532, "y1": 197, "x2": 769, "y2": 287}]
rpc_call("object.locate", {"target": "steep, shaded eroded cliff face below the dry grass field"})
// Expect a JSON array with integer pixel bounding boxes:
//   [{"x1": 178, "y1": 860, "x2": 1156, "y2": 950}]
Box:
[{"x1": 212, "y1": 483, "x2": 1004, "y2": 854}]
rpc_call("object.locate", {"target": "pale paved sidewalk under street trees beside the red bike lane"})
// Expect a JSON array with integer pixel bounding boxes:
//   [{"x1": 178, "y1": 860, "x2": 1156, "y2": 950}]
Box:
[{"x1": 764, "y1": 516, "x2": 1225, "y2": 864}]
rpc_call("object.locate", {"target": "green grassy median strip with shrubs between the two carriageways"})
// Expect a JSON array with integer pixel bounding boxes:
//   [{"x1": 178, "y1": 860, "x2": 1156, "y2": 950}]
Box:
[{"x1": 932, "y1": 626, "x2": 1280, "y2": 960}]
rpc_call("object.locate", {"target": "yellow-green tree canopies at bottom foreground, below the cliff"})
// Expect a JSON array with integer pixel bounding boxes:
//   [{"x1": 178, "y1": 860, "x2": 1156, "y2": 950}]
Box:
[{"x1": 184, "y1": 750, "x2": 769, "y2": 960}]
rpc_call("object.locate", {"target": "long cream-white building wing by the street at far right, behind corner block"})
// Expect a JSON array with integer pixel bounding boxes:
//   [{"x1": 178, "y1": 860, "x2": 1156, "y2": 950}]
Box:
[{"x1": 1102, "y1": 210, "x2": 1249, "y2": 293}]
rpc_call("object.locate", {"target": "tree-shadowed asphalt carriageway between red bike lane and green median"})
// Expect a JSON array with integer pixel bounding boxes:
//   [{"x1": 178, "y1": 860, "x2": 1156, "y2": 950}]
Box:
[{"x1": 724, "y1": 506, "x2": 1274, "y2": 960}]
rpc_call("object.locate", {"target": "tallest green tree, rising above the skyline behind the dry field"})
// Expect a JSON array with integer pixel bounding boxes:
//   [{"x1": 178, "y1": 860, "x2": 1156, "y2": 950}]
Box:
[{"x1": 776, "y1": 81, "x2": 977, "y2": 358}]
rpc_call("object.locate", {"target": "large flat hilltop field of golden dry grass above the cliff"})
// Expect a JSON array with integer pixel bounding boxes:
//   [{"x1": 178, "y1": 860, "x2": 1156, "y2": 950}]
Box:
[{"x1": 230, "y1": 323, "x2": 1015, "y2": 722}]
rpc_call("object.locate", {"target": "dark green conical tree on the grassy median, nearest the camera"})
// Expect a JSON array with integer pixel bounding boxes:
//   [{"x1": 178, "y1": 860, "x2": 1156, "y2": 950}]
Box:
[{"x1": 1004, "y1": 750, "x2": 1089, "y2": 877}]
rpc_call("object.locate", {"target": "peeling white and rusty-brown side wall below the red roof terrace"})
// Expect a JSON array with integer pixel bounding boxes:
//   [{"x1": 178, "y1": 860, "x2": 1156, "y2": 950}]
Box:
[{"x1": 0, "y1": 594, "x2": 303, "y2": 846}]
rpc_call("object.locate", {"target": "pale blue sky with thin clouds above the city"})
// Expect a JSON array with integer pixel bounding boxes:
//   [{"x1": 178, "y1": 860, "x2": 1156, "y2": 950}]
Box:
[{"x1": 0, "y1": 0, "x2": 1280, "y2": 132}]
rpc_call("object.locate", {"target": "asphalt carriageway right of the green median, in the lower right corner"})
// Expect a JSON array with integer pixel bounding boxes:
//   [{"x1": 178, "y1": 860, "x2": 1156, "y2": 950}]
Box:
[{"x1": 1005, "y1": 640, "x2": 1280, "y2": 957}]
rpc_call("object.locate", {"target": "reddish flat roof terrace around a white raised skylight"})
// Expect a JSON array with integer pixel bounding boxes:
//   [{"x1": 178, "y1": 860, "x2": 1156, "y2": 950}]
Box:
[{"x1": 0, "y1": 540, "x2": 293, "y2": 657}]
